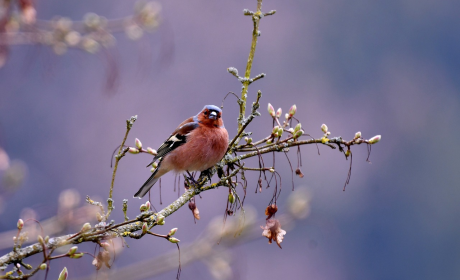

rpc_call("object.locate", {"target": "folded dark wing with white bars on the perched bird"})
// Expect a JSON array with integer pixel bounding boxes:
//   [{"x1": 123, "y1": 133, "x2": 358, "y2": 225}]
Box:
[{"x1": 147, "y1": 118, "x2": 198, "y2": 167}]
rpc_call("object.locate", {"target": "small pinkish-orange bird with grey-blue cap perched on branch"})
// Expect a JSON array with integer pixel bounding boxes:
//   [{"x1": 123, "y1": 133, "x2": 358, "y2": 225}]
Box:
[{"x1": 134, "y1": 105, "x2": 228, "y2": 198}]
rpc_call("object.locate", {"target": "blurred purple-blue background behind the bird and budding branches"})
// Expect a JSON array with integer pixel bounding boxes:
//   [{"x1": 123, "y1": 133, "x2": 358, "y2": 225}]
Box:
[{"x1": 0, "y1": 0, "x2": 460, "y2": 280}]
